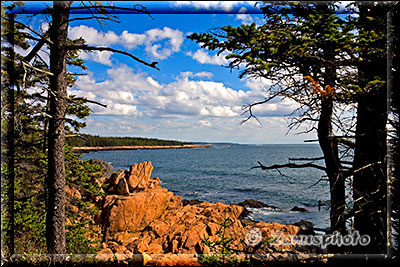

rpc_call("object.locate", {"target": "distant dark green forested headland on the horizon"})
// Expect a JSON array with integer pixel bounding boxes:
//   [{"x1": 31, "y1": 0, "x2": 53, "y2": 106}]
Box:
[{"x1": 66, "y1": 134, "x2": 191, "y2": 147}]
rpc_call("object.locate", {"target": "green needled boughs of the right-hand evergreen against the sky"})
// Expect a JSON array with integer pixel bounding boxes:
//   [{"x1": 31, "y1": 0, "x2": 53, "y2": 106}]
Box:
[{"x1": 188, "y1": 1, "x2": 386, "y2": 109}]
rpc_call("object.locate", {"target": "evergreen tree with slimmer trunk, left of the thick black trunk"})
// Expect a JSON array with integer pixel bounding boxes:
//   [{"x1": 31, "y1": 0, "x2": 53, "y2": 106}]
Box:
[{"x1": 189, "y1": 2, "x2": 355, "y2": 237}]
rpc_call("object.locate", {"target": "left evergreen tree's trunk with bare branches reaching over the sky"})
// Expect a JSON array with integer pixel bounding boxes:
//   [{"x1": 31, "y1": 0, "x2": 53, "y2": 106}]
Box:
[{"x1": 2, "y1": 1, "x2": 158, "y2": 260}]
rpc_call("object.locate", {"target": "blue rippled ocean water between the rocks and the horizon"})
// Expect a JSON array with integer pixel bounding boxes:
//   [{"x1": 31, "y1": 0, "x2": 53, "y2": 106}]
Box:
[{"x1": 82, "y1": 144, "x2": 329, "y2": 228}]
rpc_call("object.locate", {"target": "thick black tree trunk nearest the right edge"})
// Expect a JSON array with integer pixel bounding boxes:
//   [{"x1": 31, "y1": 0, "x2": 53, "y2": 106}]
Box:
[{"x1": 353, "y1": 4, "x2": 387, "y2": 253}]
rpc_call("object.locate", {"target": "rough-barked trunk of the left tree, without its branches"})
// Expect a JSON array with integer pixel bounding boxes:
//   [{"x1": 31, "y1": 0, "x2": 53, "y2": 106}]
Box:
[{"x1": 46, "y1": 1, "x2": 71, "y2": 254}]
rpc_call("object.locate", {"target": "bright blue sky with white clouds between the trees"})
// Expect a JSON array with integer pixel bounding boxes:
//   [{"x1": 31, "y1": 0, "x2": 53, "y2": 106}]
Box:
[{"x1": 17, "y1": 1, "x2": 315, "y2": 144}]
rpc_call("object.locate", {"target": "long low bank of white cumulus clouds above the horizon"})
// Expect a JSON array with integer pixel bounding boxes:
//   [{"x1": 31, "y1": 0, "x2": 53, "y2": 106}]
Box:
[{"x1": 73, "y1": 65, "x2": 295, "y2": 120}]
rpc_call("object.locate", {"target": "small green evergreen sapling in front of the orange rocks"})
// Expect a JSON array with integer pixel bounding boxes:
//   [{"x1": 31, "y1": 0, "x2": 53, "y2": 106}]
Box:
[{"x1": 199, "y1": 211, "x2": 250, "y2": 266}]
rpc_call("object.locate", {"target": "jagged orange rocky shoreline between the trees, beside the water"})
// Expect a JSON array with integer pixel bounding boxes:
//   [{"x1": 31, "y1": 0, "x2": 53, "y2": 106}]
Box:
[{"x1": 66, "y1": 160, "x2": 328, "y2": 266}]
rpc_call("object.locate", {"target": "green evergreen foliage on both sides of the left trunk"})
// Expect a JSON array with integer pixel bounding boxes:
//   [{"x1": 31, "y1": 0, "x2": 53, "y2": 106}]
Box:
[{"x1": 1, "y1": 2, "x2": 106, "y2": 256}]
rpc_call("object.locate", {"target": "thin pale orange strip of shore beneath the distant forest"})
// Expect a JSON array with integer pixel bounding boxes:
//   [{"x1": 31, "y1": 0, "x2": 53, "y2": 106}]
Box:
[{"x1": 72, "y1": 144, "x2": 211, "y2": 153}]
